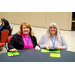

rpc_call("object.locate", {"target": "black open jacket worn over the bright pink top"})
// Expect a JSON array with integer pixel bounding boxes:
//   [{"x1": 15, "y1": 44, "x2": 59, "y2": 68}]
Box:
[{"x1": 8, "y1": 33, "x2": 37, "y2": 50}]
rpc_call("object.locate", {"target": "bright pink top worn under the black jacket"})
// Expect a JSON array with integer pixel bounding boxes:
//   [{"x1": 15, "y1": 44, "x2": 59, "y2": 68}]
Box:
[{"x1": 22, "y1": 34, "x2": 33, "y2": 49}]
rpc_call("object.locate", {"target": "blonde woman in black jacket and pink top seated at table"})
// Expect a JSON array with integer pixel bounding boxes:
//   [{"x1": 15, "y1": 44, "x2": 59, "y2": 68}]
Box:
[{"x1": 8, "y1": 22, "x2": 40, "y2": 52}]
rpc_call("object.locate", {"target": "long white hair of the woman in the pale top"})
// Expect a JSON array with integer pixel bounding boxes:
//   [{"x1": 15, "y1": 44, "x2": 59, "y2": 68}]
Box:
[{"x1": 47, "y1": 22, "x2": 61, "y2": 44}]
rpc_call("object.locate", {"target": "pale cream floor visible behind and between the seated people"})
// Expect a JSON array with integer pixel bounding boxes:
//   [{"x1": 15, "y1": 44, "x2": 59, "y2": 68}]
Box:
[{"x1": 0, "y1": 24, "x2": 75, "y2": 54}]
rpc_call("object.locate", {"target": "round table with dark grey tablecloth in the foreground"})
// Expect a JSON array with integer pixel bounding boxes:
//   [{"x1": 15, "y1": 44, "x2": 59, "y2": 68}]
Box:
[{"x1": 0, "y1": 49, "x2": 75, "y2": 62}]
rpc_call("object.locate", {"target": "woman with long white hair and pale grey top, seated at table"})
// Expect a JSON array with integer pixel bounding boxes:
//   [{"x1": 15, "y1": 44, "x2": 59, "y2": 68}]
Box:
[{"x1": 39, "y1": 22, "x2": 67, "y2": 50}]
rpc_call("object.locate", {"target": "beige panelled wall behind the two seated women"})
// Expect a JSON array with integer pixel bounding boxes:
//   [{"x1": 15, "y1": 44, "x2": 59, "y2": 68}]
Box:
[{"x1": 0, "y1": 12, "x2": 72, "y2": 30}]
